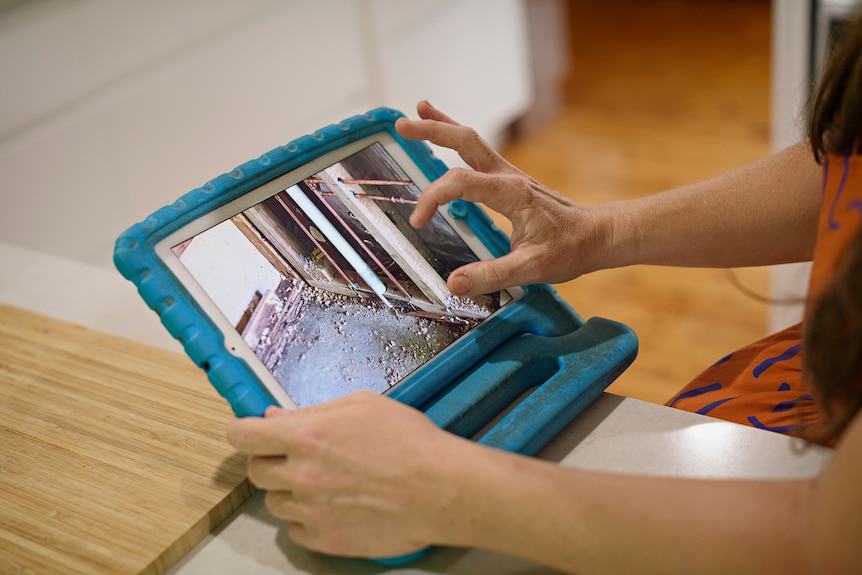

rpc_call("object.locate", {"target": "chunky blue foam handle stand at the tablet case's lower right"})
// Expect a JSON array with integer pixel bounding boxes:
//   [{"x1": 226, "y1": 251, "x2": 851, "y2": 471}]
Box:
[{"x1": 374, "y1": 318, "x2": 638, "y2": 565}]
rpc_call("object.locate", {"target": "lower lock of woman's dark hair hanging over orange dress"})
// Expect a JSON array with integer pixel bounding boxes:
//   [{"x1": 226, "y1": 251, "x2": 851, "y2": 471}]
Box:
[{"x1": 802, "y1": 228, "x2": 862, "y2": 443}]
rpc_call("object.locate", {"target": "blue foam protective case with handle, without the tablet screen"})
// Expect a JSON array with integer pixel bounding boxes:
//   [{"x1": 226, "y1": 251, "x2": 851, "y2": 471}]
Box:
[{"x1": 114, "y1": 108, "x2": 637, "y2": 563}]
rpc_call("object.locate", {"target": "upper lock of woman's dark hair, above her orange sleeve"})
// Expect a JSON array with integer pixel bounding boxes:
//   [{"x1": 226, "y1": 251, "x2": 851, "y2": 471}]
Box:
[{"x1": 808, "y1": 11, "x2": 862, "y2": 162}]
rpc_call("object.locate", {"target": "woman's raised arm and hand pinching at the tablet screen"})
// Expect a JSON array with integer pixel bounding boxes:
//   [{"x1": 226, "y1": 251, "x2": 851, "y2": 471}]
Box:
[{"x1": 396, "y1": 102, "x2": 821, "y2": 294}]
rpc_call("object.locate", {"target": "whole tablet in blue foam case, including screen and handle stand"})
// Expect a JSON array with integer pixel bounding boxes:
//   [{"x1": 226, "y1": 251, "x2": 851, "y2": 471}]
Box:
[{"x1": 114, "y1": 108, "x2": 637, "y2": 565}]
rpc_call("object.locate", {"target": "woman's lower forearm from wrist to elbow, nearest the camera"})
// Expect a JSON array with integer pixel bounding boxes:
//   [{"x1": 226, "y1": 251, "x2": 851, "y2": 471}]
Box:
[{"x1": 438, "y1": 446, "x2": 812, "y2": 575}]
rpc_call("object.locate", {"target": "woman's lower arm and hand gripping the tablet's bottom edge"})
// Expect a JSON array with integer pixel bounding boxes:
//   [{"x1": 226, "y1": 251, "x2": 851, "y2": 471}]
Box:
[{"x1": 228, "y1": 393, "x2": 862, "y2": 575}]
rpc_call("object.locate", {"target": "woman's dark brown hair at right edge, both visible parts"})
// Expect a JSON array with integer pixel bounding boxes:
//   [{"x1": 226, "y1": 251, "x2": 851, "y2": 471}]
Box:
[{"x1": 803, "y1": 11, "x2": 862, "y2": 443}]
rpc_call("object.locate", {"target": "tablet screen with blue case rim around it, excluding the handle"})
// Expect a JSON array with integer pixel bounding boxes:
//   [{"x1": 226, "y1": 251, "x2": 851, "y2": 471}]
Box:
[{"x1": 115, "y1": 109, "x2": 523, "y2": 415}]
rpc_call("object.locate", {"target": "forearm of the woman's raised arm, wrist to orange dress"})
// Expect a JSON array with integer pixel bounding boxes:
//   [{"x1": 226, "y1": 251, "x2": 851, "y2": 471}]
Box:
[{"x1": 597, "y1": 142, "x2": 822, "y2": 267}]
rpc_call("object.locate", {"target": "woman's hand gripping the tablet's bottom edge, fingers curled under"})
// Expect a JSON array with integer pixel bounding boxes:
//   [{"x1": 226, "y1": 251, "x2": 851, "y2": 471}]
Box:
[{"x1": 228, "y1": 392, "x2": 467, "y2": 557}]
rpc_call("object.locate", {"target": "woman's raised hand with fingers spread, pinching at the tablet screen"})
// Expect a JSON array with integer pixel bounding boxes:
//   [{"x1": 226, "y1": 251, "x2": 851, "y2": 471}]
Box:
[{"x1": 395, "y1": 101, "x2": 613, "y2": 295}]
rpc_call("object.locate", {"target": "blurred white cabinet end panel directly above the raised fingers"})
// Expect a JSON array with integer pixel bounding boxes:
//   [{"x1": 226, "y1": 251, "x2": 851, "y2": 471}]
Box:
[{"x1": 371, "y1": 0, "x2": 532, "y2": 153}]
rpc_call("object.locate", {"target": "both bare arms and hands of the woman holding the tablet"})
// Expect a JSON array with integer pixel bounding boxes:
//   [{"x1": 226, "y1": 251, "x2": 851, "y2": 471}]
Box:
[{"x1": 228, "y1": 103, "x2": 862, "y2": 574}]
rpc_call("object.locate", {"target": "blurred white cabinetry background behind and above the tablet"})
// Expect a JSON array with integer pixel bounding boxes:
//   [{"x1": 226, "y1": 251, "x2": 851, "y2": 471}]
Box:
[{"x1": 0, "y1": 0, "x2": 532, "y2": 273}]
